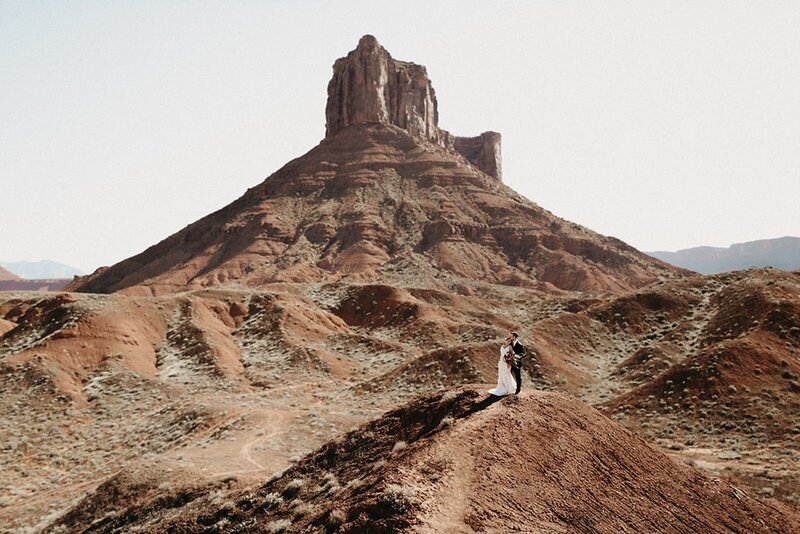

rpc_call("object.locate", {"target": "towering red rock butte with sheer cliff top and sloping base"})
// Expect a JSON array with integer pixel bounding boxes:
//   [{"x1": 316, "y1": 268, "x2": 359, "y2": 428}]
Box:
[{"x1": 69, "y1": 36, "x2": 683, "y2": 294}]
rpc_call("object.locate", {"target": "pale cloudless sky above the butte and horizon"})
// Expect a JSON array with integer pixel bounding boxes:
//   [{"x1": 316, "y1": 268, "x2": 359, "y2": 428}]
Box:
[{"x1": 0, "y1": 0, "x2": 800, "y2": 271}]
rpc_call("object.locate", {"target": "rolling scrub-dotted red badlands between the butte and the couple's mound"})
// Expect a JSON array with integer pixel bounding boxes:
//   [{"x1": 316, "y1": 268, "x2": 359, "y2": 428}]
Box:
[{"x1": 0, "y1": 270, "x2": 800, "y2": 525}]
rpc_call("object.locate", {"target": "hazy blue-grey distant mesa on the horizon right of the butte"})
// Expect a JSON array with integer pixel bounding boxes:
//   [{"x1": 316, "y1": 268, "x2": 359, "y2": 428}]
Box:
[{"x1": 647, "y1": 236, "x2": 800, "y2": 274}]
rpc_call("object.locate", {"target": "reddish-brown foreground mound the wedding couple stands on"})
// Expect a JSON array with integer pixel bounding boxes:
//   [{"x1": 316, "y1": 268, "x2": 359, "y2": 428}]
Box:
[{"x1": 48, "y1": 388, "x2": 800, "y2": 533}]
